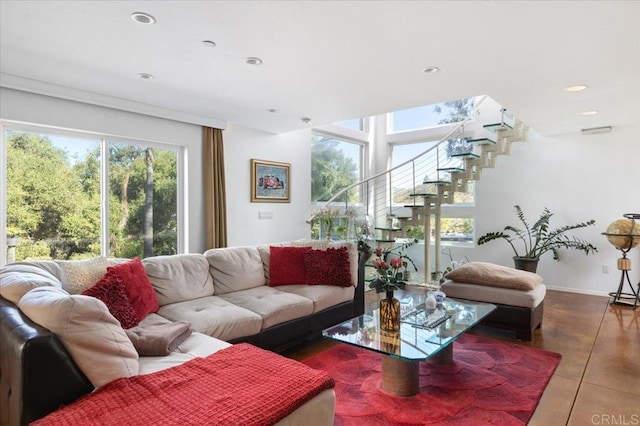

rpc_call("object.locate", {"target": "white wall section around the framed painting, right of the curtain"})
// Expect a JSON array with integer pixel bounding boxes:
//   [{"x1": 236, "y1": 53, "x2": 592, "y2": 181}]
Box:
[{"x1": 223, "y1": 123, "x2": 311, "y2": 246}]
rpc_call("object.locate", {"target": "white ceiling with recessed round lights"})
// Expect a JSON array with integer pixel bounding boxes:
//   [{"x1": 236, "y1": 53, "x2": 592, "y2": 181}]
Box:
[{"x1": 0, "y1": 0, "x2": 640, "y2": 135}]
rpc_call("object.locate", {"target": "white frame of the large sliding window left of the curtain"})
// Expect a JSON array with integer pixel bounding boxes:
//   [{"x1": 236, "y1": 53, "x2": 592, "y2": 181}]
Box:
[{"x1": 0, "y1": 120, "x2": 188, "y2": 266}]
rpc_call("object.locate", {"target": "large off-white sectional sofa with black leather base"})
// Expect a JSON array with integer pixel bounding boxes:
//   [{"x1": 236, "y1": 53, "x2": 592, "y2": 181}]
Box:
[{"x1": 0, "y1": 240, "x2": 366, "y2": 426}]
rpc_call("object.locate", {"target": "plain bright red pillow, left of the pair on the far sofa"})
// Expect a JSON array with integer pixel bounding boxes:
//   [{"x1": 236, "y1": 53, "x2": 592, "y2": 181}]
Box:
[{"x1": 269, "y1": 246, "x2": 311, "y2": 287}]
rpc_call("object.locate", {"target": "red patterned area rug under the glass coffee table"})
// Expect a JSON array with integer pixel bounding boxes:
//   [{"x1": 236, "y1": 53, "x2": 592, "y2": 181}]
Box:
[{"x1": 302, "y1": 334, "x2": 561, "y2": 426}]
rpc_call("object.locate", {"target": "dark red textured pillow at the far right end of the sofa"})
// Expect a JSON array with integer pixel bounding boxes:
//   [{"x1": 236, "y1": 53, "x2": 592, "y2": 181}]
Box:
[{"x1": 304, "y1": 247, "x2": 352, "y2": 287}]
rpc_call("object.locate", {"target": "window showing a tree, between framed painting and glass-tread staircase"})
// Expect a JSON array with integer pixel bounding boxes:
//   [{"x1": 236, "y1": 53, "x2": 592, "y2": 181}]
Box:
[{"x1": 311, "y1": 134, "x2": 363, "y2": 203}]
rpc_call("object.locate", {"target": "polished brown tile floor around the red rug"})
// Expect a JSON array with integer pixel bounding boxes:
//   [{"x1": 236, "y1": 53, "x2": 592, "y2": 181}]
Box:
[{"x1": 284, "y1": 287, "x2": 640, "y2": 426}]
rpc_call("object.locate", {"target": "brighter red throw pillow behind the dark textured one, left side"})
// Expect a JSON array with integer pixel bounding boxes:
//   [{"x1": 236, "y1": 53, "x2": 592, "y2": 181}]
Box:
[{"x1": 83, "y1": 257, "x2": 160, "y2": 328}]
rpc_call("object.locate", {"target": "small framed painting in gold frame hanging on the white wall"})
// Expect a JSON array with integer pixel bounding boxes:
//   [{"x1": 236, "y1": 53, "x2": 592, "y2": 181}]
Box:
[{"x1": 251, "y1": 159, "x2": 291, "y2": 203}]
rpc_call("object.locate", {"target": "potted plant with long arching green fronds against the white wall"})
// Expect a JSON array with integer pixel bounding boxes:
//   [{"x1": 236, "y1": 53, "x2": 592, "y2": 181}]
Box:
[{"x1": 478, "y1": 206, "x2": 598, "y2": 272}]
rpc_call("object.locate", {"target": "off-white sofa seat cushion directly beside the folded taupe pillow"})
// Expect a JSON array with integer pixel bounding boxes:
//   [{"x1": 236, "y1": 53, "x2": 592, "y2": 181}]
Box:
[{"x1": 158, "y1": 296, "x2": 262, "y2": 340}]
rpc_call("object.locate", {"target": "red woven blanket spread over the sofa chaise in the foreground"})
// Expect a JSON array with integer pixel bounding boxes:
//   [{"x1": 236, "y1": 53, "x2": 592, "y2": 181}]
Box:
[{"x1": 33, "y1": 344, "x2": 334, "y2": 426}]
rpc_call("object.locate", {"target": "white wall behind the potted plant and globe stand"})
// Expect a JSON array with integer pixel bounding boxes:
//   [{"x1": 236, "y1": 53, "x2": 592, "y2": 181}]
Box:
[{"x1": 452, "y1": 126, "x2": 640, "y2": 295}]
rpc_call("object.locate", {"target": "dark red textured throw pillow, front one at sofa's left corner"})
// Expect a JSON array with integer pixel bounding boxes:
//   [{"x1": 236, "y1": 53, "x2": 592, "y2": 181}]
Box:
[{"x1": 82, "y1": 275, "x2": 140, "y2": 328}]
